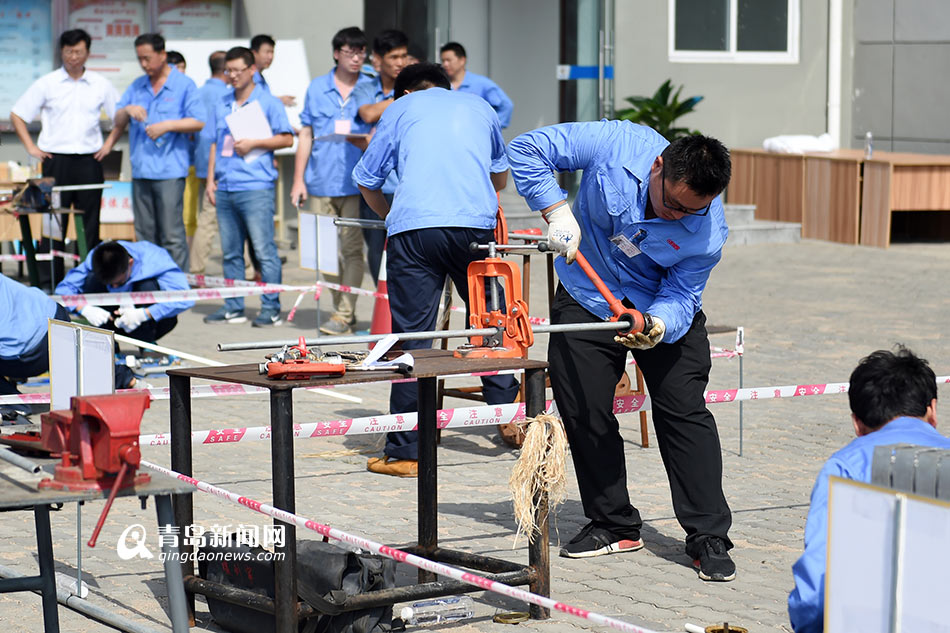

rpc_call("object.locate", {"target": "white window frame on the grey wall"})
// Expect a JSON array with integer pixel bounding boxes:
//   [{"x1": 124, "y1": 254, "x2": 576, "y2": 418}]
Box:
[{"x1": 667, "y1": 0, "x2": 801, "y2": 64}]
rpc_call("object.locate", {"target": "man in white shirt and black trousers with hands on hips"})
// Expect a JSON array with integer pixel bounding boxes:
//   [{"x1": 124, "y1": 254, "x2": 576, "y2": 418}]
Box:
[{"x1": 10, "y1": 29, "x2": 118, "y2": 287}]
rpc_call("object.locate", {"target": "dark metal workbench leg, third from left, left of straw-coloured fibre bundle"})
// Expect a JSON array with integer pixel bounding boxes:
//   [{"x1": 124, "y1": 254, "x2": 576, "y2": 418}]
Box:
[{"x1": 417, "y1": 377, "x2": 439, "y2": 583}]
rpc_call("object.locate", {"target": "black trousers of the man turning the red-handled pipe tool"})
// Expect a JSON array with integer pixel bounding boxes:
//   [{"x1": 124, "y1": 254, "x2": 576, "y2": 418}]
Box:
[{"x1": 548, "y1": 286, "x2": 732, "y2": 557}]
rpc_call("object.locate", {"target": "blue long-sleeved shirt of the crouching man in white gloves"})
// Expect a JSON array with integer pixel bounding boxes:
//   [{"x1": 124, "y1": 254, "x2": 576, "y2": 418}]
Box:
[{"x1": 56, "y1": 241, "x2": 195, "y2": 321}]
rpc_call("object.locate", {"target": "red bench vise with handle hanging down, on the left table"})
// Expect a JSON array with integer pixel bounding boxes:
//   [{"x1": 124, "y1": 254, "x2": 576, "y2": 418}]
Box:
[{"x1": 39, "y1": 392, "x2": 151, "y2": 547}]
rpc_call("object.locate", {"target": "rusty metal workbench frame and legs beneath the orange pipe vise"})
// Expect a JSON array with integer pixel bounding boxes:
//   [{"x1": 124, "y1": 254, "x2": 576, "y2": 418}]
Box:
[{"x1": 167, "y1": 350, "x2": 550, "y2": 633}]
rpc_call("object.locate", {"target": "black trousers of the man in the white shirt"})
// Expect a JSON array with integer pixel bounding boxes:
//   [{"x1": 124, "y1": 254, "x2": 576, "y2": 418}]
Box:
[{"x1": 36, "y1": 154, "x2": 103, "y2": 288}]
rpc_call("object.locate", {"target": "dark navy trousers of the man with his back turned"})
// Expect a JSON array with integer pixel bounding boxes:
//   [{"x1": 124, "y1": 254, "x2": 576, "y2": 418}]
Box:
[{"x1": 384, "y1": 227, "x2": 519, "y2": 459}]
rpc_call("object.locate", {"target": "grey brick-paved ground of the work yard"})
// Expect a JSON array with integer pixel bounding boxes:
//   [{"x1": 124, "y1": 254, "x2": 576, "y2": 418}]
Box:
[{"x1": 0, "y1": 194, "x2": 950, "y2": 633}]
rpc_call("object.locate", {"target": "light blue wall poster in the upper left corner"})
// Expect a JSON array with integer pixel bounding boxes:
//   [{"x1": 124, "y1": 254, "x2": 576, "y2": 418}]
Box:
[{"x1": 0, "y1": 0, "x2": 53, "y2": 120}]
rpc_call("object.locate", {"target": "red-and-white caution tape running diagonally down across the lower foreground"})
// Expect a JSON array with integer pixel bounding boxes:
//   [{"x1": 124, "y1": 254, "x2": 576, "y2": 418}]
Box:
[{"x1": 142, "y1": 460, "x2": 654, "y2": 633}]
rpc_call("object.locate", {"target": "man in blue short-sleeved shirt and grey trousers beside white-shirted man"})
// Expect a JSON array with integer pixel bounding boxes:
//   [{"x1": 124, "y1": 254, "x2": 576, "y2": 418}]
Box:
[{"x1": 104, "y1": 33, "x2": 205, "y2": 270}]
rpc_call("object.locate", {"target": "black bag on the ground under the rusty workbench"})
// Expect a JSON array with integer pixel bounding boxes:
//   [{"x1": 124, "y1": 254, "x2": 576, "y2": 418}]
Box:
[{"x1": 198, "y1": 541, "x2": 396, "y2": 633}]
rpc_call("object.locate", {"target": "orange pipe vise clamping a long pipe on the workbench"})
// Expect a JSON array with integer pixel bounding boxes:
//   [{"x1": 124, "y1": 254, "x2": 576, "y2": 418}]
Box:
[{"x1": 454, "y1": 250, "x2": 534, "y2": 358}]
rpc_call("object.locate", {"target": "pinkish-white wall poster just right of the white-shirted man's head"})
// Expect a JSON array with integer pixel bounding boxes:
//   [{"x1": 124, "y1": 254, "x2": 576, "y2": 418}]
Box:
[{"x1": 69, "y1": 0, "x2": 148, "y2": 95}]
